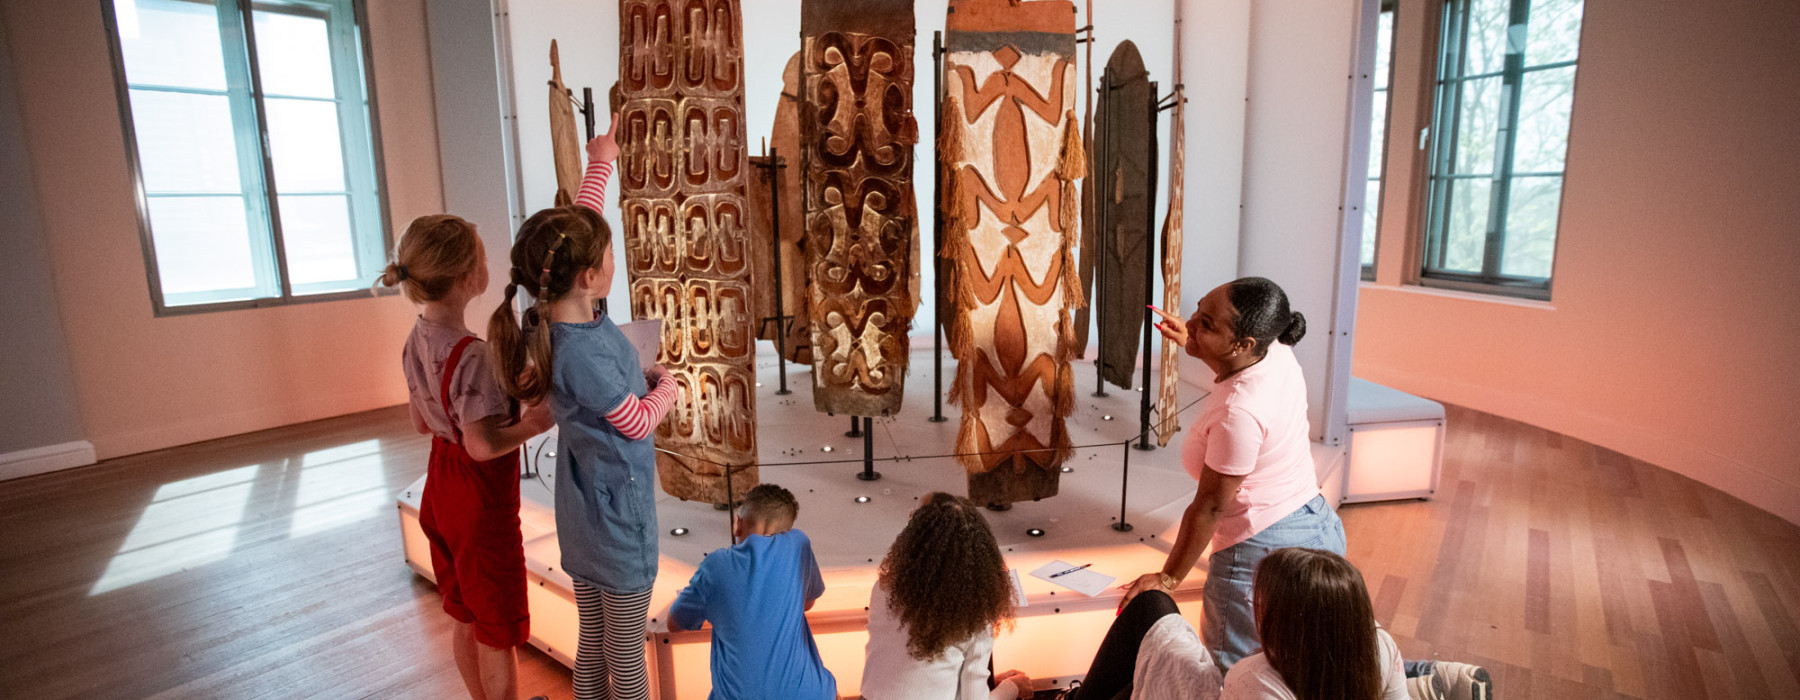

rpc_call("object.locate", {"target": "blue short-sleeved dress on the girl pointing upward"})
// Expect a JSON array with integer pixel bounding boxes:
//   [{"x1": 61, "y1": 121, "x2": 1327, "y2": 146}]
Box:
[{"x1": 551, "y1": 315, "x2": 657, "y2": 594}]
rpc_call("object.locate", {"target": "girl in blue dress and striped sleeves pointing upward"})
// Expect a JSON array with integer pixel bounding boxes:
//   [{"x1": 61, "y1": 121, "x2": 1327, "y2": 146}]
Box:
[{"x1": 488, "y1": 115, "x2": 675, "y2": 700}]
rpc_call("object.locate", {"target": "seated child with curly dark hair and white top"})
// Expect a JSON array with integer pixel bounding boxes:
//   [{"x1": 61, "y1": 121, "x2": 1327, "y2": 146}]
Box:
[{"x1": 862, "y1": 493, "x2": 1031, "y2": 700}]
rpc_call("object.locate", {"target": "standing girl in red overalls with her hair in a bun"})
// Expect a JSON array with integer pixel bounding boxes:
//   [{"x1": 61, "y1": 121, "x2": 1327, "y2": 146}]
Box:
[{"x1": 382, "y1": 214, "x2": 553, "y2": 700}]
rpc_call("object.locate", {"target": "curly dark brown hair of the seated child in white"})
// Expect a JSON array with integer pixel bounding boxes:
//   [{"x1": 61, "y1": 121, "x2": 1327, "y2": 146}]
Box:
[{"x1": 877, "y1": 493, "x2": 1013, "y2": 660}]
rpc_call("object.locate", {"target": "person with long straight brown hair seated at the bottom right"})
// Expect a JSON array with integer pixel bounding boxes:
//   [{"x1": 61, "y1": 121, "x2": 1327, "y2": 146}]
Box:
[{"x1": 1222, "y1": 547, "x2": 1406, "y2": 700}]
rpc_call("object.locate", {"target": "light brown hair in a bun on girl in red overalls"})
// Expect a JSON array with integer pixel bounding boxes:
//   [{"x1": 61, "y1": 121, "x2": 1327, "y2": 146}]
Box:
[{"x1": 376, "y1": 214, "x2": 486, "y2": 304}]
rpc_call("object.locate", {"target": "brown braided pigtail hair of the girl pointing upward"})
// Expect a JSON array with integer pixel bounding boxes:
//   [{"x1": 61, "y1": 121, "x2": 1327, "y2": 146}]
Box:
[{"x1": 488, "y1": 205, "x2": 612, "y2": 403}]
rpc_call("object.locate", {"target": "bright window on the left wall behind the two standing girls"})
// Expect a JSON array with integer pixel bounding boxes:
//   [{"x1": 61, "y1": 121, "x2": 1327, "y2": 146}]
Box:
[{"x1": 103, "y1": 0, "x2": 387, "y2": 313}]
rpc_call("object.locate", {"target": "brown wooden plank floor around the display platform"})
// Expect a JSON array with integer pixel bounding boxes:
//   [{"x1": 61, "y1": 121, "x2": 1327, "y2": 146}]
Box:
[{"x1": 0, "y1": 407, "x2": 1800, "y2": 700}]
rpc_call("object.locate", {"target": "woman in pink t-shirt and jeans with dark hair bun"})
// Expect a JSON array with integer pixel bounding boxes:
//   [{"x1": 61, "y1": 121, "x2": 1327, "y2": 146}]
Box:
[{"x1": 1120, "y1": 277, "x2": 1345, "y2": 669}]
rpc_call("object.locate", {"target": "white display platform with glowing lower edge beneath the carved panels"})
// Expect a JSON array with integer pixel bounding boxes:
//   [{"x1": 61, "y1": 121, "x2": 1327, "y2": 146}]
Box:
[{"x1": 400, "y1": 347, "x2": 1343, "y2": 698}]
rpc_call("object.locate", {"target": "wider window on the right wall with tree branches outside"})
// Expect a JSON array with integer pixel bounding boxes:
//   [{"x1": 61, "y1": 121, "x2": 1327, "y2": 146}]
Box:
[{"x1": 1422, "y1": 0, "x2": 1582, "y2": 299}]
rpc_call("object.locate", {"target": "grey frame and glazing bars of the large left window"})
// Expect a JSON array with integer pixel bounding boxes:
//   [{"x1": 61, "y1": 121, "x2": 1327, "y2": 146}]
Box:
[{"x1": 97, "y1": 0, "x2": 398, "y2": 317}]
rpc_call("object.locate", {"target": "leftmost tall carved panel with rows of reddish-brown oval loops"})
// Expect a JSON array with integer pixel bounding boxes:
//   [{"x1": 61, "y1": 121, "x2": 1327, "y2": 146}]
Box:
[{"x1": 614, "y1": 0, "x2": 756, "y2": 502}]
